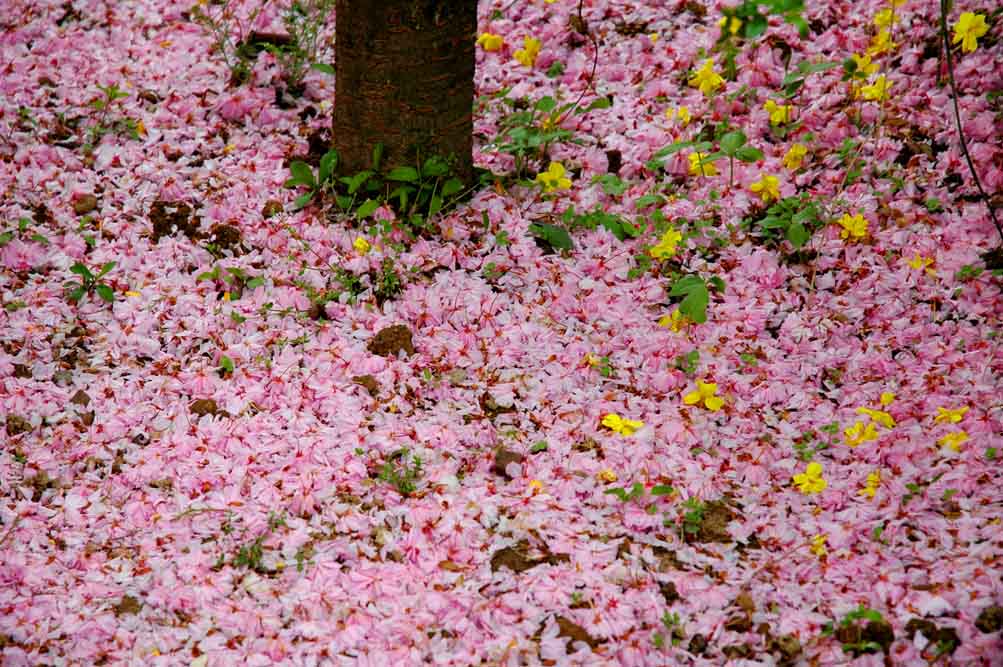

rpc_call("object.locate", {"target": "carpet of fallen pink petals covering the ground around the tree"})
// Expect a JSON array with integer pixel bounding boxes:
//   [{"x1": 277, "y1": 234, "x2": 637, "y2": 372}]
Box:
[{"x1": 0, "y1": 0, "x2": 1003, "y2": 667}]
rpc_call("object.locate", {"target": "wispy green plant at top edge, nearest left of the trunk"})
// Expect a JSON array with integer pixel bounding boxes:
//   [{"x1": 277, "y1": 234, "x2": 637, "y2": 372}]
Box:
[{"x1": 265, "y1": 0, "x2": 335, "y2": 94}]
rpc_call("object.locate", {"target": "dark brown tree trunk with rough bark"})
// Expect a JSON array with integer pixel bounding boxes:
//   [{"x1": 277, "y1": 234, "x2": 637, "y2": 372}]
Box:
[{"x1": 333, "y1": 0, "x2": 477, "y2": 182}]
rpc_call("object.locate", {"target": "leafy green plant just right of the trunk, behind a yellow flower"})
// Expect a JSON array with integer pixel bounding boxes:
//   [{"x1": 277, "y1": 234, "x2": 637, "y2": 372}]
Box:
[{"x1": 484, "y1": 89, "x2": 610, "y2": 179}]
